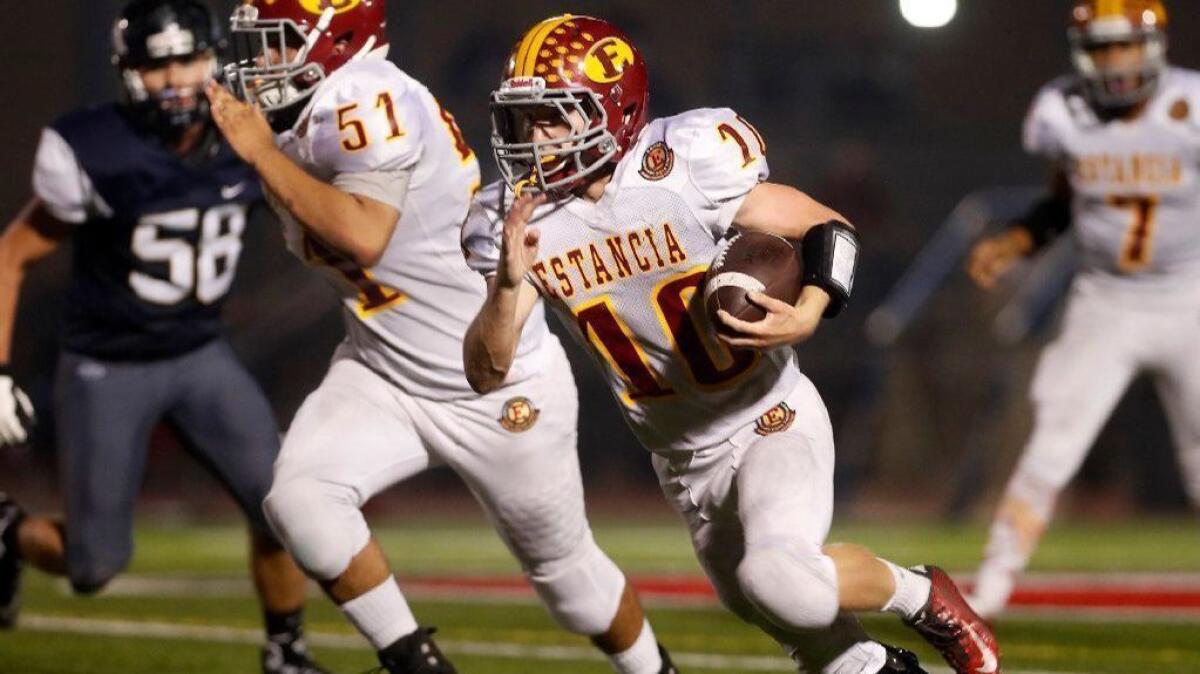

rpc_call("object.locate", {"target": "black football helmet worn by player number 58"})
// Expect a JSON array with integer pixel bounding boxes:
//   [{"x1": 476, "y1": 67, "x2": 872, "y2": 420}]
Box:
[{"x1": 113, "y1": 0, "x2": 224, "y2": 139}]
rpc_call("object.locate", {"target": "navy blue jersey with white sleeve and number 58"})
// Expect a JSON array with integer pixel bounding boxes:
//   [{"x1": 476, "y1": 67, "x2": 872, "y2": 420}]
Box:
[{"x1": 34, "y1": 104, "x2": 262, "y2": 360}]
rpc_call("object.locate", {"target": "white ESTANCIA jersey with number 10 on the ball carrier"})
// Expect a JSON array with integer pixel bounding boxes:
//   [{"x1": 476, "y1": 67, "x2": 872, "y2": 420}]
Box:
[{"x1": 463, "y1": 109, "x2": 799, "y2": 451}]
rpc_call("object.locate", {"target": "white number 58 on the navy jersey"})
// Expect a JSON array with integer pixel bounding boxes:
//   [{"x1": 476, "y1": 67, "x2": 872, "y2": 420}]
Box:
[{"x1": 130, "y1": 204, "x2": 246, "y2": 306}]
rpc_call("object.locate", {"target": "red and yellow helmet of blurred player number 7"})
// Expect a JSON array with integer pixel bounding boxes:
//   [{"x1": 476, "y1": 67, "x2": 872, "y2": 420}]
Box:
[{"x1": 1067, "y1": 0, "x2": 1166, "y2": 108}]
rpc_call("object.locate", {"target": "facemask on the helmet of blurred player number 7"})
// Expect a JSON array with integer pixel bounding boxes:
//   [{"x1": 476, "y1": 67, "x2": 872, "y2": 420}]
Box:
[{"x1": 1068, "y1": 17, "x2": 1166, "y2": 109}]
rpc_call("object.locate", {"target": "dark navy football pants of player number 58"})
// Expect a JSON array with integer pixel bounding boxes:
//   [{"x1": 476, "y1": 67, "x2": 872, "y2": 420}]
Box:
[{"x1": 55, "y1": 339, "x2": 280, "y2": 592}]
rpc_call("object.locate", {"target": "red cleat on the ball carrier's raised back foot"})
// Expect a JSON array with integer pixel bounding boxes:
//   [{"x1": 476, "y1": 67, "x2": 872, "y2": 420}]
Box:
[{"x1": 905, "y1": 566, "x2": 1000, "y2": 674}]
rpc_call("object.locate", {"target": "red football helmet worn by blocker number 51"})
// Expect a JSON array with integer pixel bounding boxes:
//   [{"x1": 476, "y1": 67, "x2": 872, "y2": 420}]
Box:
[{"x1": 226, "y1": 0, "x2": 388, "y2": 113}]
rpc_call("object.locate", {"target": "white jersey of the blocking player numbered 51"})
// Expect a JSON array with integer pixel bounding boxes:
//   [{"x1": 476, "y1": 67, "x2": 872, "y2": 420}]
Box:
[{"x1": 272, "y1": 59, "x2": 553, "y2": 399}]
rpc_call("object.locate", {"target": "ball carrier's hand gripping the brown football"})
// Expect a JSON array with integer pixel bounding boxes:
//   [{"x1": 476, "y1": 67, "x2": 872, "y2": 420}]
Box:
[{"x1": 716, "y1": 285, "x2": 829, "y2": 350}]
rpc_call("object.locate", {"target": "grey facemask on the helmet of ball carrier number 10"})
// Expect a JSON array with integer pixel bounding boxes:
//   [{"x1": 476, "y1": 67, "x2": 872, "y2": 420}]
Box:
[{"x1": 491, "y1": 77, "x2": 618, "y2": 194}]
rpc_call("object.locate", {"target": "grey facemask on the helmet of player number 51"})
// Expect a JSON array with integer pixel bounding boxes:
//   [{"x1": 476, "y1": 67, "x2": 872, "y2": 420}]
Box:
[{"x1": 224, "y1": 5, "x2": 335, "y2": 115}]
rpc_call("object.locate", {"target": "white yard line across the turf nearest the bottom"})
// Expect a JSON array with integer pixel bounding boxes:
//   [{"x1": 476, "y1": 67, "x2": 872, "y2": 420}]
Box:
[{"x1": 19, "y1": 613, "x2": 1073, "y2": 674}]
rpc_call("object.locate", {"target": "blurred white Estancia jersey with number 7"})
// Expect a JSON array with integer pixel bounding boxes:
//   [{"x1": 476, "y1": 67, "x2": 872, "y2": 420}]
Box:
[{"x1": 1025, "y1": 68, "x2": 1200, "y2": 295}]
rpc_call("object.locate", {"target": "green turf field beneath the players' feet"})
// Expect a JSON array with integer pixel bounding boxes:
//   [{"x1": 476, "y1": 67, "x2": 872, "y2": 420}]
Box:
[{"x1": 0, "y1": 513, "x2": 1200, "y2": 674}]
